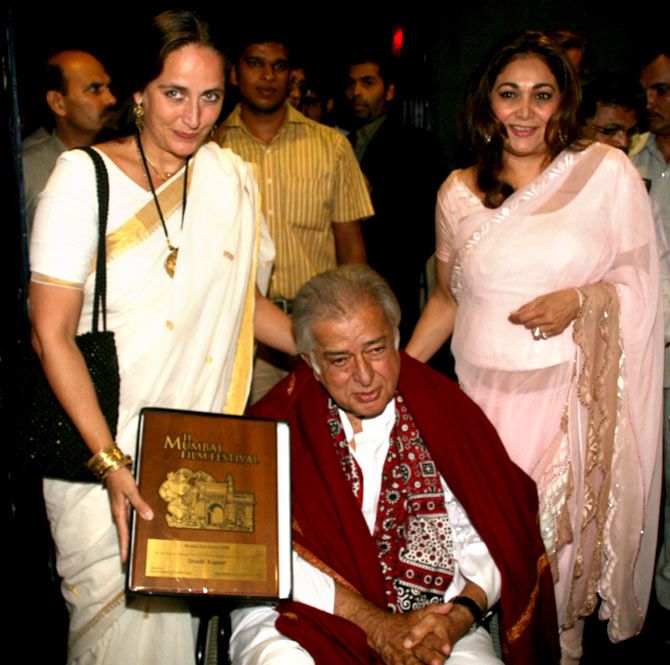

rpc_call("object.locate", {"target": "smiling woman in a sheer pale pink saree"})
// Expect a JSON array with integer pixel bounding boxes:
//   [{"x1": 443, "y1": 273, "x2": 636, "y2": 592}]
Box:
[{"x1": 407, "y1": 32, "x2": 663, "y2": 663}]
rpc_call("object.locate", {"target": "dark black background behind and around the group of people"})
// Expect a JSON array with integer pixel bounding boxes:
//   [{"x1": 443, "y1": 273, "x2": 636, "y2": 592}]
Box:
[{"x1": 0, "y1": 0, "x2": 670, "y2": 664}]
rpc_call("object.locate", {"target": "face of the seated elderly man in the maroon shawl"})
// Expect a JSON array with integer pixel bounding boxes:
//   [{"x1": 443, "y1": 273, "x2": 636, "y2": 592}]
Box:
[{"x1": 312, "y1": 303, "x2": 400, "y2": 418}]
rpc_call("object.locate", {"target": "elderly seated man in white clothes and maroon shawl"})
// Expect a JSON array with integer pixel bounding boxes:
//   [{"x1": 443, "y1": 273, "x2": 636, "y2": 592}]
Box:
[{"x1": 230, "y1": 265, "x2": 559, "y2": 665}]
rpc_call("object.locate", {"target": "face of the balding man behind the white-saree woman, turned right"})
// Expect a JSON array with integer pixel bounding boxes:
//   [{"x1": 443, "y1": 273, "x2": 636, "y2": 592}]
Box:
[{"x1": 61, "y1": 53, "x2": 116, "y2": 132}]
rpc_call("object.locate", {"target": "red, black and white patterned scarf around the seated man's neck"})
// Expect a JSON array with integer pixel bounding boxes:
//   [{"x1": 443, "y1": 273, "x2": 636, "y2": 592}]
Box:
[{"x1": 328, "y1": 394, "x2": 454, "y2": 612}]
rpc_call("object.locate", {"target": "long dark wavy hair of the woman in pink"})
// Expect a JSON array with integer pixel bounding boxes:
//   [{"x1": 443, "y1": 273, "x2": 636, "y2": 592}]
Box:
[{"x1": 462, "y1": 30, "x2": 580, "y2": 208}]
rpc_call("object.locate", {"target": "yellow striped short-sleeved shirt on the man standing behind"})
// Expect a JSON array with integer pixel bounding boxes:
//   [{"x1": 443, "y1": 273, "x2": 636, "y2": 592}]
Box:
[{"x1": 217, "y1": 105, "x2": 374, "y2": 299}]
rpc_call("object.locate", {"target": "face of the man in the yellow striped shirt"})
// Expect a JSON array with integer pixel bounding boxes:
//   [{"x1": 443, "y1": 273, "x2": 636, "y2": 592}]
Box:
[{"x1": 233, "y1": 42, "x2": 289, "y2": 113}]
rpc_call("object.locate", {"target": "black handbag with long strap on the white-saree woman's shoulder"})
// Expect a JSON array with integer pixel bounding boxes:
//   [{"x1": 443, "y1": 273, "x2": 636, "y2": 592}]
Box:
[{"x1": 15, "y1": 147, "x2": 120, "y2": 482}]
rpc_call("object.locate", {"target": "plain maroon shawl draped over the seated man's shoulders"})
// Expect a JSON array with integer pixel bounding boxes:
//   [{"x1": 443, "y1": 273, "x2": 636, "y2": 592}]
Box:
[{"x1": 251, "y1": 353, "x2": 560, "y2": 665}]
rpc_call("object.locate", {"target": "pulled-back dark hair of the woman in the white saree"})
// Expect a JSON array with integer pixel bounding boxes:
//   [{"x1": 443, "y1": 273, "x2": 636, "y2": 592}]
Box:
[{"x1": 108, "y1": 9, "x2": 227, "y2": 136}]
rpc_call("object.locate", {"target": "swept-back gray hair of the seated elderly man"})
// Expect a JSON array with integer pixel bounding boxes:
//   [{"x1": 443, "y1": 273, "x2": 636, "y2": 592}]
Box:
[{"x1": 292, "y1": 264, "x2": 400, "y2": 369}]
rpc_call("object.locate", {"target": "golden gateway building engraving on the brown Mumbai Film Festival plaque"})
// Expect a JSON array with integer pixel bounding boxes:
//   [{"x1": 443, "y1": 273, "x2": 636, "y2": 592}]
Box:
[{"x1": 158, "y1": 469, "x2": 256, "y2": 533}]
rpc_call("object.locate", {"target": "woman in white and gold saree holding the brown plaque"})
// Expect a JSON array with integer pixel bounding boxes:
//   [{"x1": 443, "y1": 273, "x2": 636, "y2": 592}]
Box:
[{"x1": 30, "y1": 11, "x2": 293, "y2": 665}]
